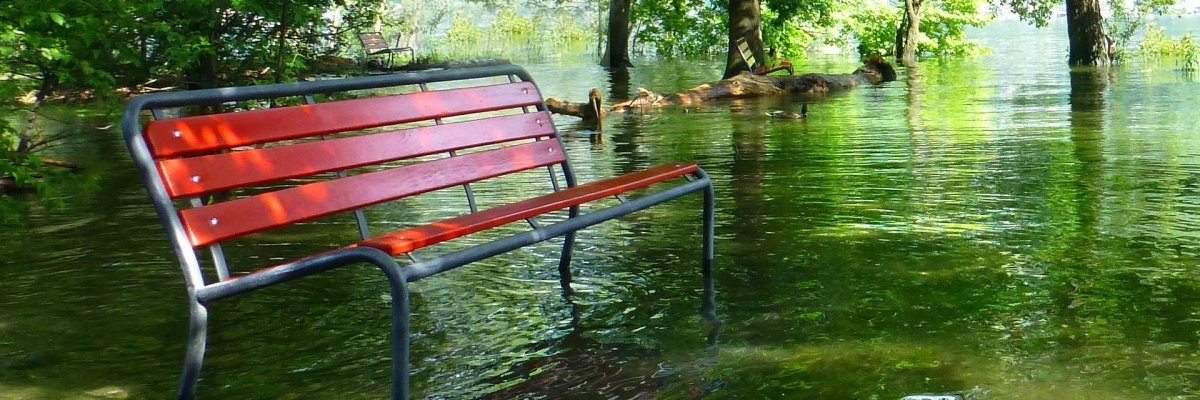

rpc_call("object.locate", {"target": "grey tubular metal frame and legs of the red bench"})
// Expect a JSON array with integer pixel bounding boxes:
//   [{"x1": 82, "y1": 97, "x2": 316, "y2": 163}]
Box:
[{"x1": 121, "y1": 65, "x2": 719, "y2": 399}]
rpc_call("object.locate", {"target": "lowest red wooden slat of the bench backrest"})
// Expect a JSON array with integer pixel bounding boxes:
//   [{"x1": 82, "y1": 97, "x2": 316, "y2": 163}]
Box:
[{"x1": 179, "y1": 141, "x2": 565, "y2": 246}]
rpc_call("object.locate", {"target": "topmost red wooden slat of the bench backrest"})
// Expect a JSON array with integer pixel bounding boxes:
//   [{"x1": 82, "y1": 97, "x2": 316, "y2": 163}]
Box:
[{"x1": 145, "y1": 82, "x2": 541, "y2": 157}]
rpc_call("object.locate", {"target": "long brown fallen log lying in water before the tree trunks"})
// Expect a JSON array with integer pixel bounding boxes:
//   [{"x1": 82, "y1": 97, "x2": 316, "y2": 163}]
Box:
[{"x1": 546, "y1": 58, "x2": 896, "y2": 121}]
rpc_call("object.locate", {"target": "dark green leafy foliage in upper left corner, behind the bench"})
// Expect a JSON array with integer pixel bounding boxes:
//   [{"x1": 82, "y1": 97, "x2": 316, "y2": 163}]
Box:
[{"x1": 0, "y1": 0, "x2": 382, "y2": 96}]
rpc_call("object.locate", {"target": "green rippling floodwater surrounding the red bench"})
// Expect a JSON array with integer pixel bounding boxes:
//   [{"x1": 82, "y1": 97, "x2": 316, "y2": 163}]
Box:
[{"x1": 0, "y1": 18, "x2": 1200, "y2": 399}]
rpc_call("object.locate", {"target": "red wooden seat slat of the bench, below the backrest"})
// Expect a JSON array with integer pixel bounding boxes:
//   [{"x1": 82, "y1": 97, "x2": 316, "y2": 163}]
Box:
[{"x1": 358, "y1": 163, "x2": 698, "y2": 255}]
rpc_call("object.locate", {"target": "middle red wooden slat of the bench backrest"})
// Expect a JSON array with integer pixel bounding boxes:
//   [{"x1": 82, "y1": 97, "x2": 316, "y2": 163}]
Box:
[{"x1": 158, "y1": 113, "x2": 557, "y2": 198}]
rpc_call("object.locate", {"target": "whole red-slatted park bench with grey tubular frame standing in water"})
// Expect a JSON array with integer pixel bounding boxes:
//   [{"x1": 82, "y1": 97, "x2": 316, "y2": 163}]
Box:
[{"x1": 121, "y1": 65, "x2": 714, "y2": 399}]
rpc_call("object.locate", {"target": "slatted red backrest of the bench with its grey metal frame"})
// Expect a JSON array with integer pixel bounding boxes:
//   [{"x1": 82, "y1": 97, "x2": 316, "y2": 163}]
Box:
[{"x1": 122, "y1": 66, "x2": 575, "y2": 285}]
